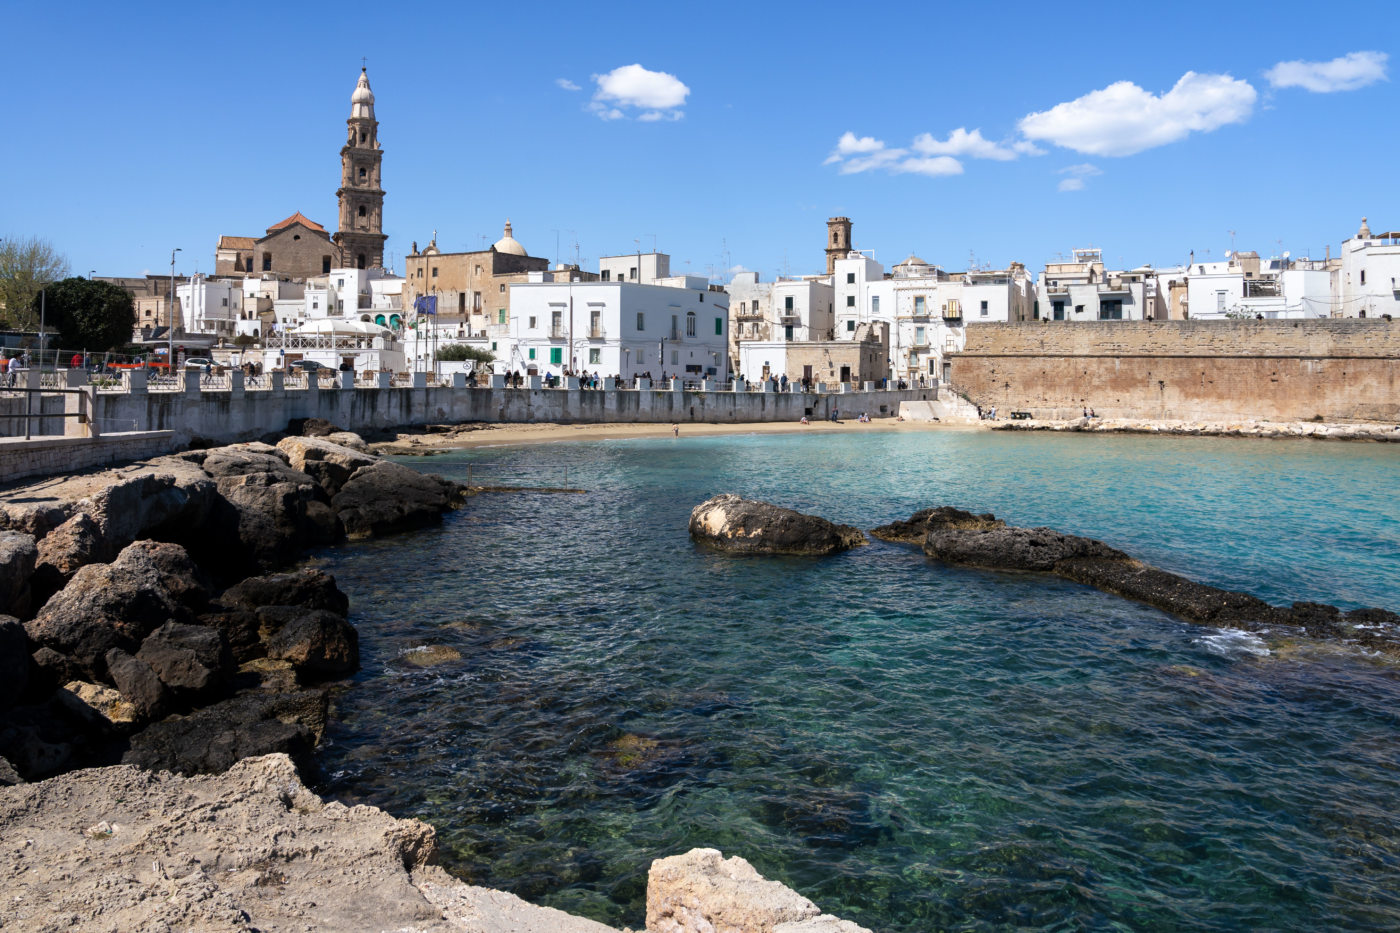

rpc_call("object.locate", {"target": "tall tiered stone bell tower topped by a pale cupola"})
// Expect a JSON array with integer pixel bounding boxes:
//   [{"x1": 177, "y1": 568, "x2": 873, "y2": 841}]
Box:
[{"x1": 336, "y1": 69, "x2": 386, "y2": 269}]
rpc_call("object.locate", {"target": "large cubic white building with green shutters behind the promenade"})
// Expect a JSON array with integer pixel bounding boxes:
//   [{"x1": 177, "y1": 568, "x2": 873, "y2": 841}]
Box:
[{"x1": 515, "y1": 277, "x2": 729, "y2": 380}]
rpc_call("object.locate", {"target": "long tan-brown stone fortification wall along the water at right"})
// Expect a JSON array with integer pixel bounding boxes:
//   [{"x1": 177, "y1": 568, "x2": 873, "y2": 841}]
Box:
[{"x1": 949, "y1": 319, "x2": 1400, "y2": 422}]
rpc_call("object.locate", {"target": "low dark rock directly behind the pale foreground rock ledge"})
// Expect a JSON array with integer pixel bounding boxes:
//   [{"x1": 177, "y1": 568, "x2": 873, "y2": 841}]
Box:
[{"x1": 122, "y1": 691, "x2": 329, "y2": 775}]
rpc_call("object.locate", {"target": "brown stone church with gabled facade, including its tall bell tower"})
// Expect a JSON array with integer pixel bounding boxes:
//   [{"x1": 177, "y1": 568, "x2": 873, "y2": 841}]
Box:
[{"x1": 214, "y1": 69, "x2": 388, "y2": 279}]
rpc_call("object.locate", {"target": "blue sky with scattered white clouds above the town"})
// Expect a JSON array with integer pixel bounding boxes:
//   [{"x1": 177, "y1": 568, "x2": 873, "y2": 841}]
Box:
[{"x1": 0, "y1": 0, "x2": 1400, "y2": 282}]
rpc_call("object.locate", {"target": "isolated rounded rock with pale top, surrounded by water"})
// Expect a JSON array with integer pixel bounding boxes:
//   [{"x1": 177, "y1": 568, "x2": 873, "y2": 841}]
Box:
[{"x1": 690, "y1": 493, "x2": 868, "y2": 555}]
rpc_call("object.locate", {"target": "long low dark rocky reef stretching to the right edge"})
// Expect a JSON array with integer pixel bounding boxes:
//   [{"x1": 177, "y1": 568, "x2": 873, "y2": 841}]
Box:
[{"x1": 871, "y1": 506, "x2": 1400, "y2": 656}]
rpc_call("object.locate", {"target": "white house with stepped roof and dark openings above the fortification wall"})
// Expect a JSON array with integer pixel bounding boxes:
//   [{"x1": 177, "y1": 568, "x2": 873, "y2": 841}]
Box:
[{"x1": 1032, "y1": 249, "x2": 1168, "y2": 321}]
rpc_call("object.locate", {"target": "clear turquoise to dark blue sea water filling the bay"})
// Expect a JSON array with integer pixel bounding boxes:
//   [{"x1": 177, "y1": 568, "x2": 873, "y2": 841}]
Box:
[{"x1": 312, "y1": 433, "x2": 1400, "y2": 930}]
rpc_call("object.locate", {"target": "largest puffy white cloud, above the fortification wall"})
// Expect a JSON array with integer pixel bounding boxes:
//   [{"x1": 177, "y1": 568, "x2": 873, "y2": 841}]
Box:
[{"x1": 1019, "y1": 71, "x2": 1259, "y2": 156}]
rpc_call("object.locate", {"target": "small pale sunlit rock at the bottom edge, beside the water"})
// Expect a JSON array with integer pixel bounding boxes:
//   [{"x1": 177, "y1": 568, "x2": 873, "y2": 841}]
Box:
[{"x1": 647, "y1": 849, "x2": 868, "y2": 933}]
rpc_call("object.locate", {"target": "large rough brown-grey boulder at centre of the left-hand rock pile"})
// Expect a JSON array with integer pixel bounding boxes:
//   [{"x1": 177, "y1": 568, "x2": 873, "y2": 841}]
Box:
[{"x1": 25, "y1": 541, "x2": 209, "y2": 679}]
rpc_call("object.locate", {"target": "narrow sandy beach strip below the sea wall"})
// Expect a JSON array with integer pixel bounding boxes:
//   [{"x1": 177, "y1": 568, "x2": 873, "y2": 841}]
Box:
[{"x1": 372, "y1": 417, "x2": 990, "y2": 454}]
